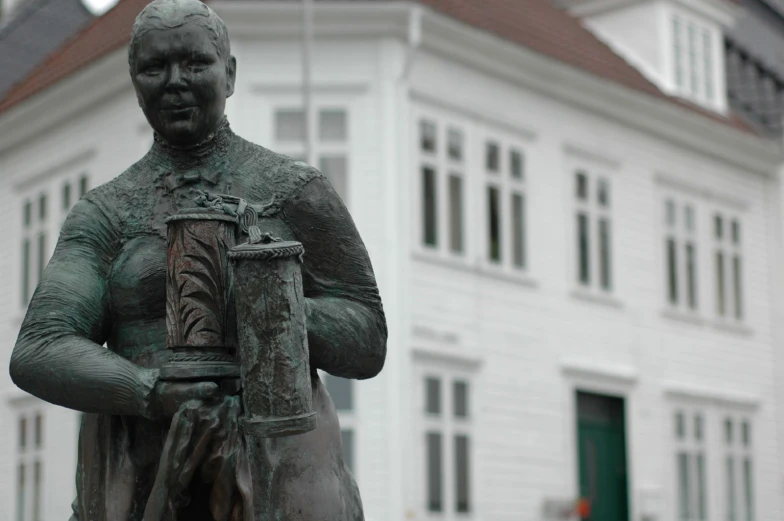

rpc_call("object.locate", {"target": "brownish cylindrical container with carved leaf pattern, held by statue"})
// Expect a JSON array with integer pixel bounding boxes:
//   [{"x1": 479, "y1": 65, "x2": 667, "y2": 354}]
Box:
[{"x1": 161, "y1": 208, "x2": 239, "y2": 380}]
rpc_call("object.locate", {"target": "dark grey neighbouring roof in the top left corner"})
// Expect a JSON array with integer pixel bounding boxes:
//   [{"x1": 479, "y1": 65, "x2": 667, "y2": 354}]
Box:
[{"x1": 0, "y1": 0, "x2": 94, "y2": 97}]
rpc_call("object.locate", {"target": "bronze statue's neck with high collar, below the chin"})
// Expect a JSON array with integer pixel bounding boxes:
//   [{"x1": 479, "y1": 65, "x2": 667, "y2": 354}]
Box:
[{"x1": 150, "y1": 116, "x2": 234, "y2": 169}]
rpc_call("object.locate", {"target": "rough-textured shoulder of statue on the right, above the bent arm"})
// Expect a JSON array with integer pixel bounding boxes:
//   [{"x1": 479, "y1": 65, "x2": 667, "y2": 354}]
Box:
[{"x1": 233, "y1": 136, "x2": 322, "y2": 203}]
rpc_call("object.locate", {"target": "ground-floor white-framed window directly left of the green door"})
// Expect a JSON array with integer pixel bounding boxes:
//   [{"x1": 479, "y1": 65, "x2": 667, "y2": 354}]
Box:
[{"x1": 421, "y1": 372, "x2": 474, "y2": 519}]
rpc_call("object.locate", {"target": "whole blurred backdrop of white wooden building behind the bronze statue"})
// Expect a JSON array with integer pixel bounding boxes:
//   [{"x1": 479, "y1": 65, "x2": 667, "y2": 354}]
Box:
[{"x1": 0, "y1": 0, "x2": 784, "y2": 521}]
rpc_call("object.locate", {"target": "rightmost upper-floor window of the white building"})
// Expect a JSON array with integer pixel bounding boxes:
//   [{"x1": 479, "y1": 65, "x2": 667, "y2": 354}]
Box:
[{"x1": 712, "y1": 212, "x2": 744, "y2": 321}]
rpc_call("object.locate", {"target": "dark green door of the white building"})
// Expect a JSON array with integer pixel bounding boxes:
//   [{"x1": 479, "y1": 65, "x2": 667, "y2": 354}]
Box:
[{"x1": 577, "y1": 392, "x2": 629, "y2": 521}]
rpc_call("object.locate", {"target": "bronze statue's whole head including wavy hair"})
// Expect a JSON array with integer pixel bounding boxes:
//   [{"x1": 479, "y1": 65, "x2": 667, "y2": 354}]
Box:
[{"x1": 128, "y1": 0, "x2": 237, "y2": 146}]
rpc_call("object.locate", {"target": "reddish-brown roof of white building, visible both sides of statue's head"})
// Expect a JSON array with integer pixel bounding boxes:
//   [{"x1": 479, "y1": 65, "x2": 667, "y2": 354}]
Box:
[{"x1": 0, "y1": 0, "x2": 752, "y2": 132}]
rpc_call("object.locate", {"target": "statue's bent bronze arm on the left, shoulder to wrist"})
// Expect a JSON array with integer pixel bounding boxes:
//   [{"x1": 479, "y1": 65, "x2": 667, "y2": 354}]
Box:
[{"x1": 11, "y1": 199, "x2": 156, "y2": 415}]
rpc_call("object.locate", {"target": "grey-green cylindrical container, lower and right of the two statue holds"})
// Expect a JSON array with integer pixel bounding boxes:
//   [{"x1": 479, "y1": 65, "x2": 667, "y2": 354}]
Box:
[{"x1": 229, "y1": 241, "x2": 316, "y2": 438}]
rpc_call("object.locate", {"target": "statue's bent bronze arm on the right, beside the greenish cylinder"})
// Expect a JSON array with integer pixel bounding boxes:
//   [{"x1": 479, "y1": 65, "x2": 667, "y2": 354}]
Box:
[{"x1": 282, "y1": 176, "x2": 387, "y2": 379}]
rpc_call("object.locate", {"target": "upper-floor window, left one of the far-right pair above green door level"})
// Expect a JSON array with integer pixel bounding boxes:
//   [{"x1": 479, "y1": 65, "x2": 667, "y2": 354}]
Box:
[{"x1": 664, "y1": 197, "x2": 698, "y2": 312}]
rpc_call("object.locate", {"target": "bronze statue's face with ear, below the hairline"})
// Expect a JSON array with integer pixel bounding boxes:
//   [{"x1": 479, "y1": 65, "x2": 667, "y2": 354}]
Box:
[{"x1": 131, "y1": 23, "x2": 236, "y2": 146}]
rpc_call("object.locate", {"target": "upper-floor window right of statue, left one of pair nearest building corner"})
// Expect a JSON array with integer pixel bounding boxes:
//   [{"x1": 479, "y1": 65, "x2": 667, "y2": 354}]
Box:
[{"x1": 419, "y1": 118, "x2": 466, "y2": 257}]
